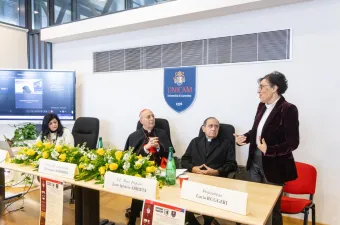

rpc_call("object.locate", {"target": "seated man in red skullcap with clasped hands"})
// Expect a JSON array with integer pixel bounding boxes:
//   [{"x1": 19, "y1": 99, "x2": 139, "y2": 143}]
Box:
[{"x1": 125, "y1": 109, "x2": 171, "y2": 225}]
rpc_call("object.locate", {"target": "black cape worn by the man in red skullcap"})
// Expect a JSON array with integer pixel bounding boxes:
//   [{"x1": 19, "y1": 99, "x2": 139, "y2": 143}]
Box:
[{"x1": 124, "y1": 128, "x2": 171, "y2": 165}]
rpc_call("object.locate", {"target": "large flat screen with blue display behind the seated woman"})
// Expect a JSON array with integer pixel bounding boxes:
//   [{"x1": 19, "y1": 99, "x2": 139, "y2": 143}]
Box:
[{"x1": 0, "y1": 69, "x2": 76, "y2": 120}]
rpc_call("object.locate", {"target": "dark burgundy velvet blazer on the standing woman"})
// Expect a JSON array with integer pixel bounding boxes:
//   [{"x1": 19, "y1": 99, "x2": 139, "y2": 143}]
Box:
[{"x1": 244, "y1": 96, "x2": 300, "y2": 183}]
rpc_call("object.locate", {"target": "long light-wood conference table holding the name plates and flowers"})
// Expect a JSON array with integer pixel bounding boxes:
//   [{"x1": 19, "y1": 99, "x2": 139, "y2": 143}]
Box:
[{"x1": 0, "y1": 162, "x2": 282, "y2": 225}]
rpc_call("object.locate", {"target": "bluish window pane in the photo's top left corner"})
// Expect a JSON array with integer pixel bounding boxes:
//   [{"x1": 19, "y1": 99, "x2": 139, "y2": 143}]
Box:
[{"x1": 0, "y1": 0, "x2": 20, "y2": 26}]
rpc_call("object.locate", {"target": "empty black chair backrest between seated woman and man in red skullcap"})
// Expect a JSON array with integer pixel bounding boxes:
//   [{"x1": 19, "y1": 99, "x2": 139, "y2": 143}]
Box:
[{"x1": 72, "y1": 117, "x2": 99, "y2": 149}]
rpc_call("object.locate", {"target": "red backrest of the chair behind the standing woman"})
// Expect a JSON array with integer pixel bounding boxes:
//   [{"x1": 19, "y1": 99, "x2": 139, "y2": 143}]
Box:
[{"x1": 283, "y1": 162, "x2": 317, "y2": 195}]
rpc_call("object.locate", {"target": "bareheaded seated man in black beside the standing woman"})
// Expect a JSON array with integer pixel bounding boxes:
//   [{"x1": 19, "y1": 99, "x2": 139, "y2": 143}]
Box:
[{"x1": 181, "y1": 117, "x2": 237, "y2": 225}]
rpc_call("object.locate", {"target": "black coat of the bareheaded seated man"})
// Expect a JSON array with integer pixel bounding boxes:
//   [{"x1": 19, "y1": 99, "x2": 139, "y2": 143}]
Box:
[{"x1": 181, "y1": 136, "x2": 237, "y2": 177}]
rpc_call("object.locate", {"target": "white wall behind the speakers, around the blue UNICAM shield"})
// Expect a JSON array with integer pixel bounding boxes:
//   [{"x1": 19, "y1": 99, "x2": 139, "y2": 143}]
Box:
[{"x1": 53, "y1": 0, "x2": 340, "y2": 225}]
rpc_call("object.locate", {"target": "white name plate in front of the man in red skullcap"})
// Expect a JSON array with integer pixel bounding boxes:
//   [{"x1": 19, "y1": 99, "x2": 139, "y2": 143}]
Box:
[{"x1": 104, "y1": 171, "x2": 157, "y2": 199}]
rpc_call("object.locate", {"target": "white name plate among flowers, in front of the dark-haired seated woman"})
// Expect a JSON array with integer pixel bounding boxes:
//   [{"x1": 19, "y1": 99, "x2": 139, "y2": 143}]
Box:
[{"x1": 39, "y1": 159, "x2": 77, "y2": 179}]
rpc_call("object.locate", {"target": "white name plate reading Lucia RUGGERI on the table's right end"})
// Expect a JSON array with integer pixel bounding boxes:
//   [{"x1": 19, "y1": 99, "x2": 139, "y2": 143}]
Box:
[{"x1": 181, "y1": 180, "x2": 248, "y2": 215}]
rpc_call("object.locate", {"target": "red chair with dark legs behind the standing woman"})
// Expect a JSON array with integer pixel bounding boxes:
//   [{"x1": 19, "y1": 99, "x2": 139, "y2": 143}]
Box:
[{"x1": 281, "y1": 162, "x2": 317, "y2": 225}]
